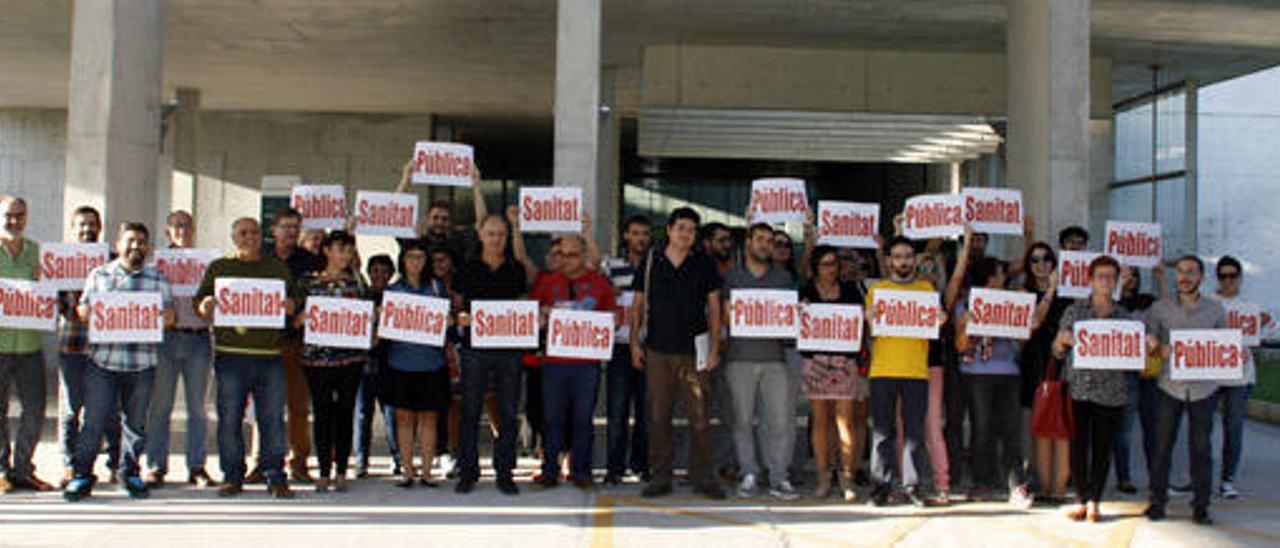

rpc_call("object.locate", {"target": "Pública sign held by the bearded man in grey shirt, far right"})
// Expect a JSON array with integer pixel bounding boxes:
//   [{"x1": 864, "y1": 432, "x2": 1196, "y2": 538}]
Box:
[{"x1": 1169, "y1": 329, "x2": 1248, "y2": 380}]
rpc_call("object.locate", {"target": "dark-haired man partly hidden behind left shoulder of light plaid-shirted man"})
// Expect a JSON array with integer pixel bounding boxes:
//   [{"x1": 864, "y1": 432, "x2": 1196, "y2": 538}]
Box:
[{"x1": 58, "y1": 205, "x2": 120, "y2": 488}]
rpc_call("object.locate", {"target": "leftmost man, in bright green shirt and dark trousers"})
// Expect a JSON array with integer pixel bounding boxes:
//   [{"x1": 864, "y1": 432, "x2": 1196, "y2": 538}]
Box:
[{"x1": 0, "y1": 196, "x2": 54, "y2": 494}]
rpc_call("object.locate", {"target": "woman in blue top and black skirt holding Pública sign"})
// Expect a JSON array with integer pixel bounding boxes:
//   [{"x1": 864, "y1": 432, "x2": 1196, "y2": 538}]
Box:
[{"x1": 378, "y1": 239, "x2": 452, "y2": 489}]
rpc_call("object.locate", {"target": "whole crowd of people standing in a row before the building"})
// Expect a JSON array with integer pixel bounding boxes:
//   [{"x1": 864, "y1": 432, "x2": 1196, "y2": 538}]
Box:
[{"x1": 0, "y1": 166, "x2": 1254, "y2": 524}]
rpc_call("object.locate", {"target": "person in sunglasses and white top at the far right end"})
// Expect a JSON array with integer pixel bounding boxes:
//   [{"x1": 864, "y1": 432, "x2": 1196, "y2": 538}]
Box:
[{"x1": 1213, "y1": 255, "x2": 1271, "y2": 499}]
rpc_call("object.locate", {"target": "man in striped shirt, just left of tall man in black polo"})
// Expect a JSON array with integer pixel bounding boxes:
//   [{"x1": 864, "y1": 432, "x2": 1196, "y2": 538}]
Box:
[{"x1": 604, "y1": 215, "x2": 653, "y2": 485}]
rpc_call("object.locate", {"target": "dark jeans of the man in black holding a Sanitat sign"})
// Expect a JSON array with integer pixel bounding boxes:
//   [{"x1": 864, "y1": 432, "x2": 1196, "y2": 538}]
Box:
[{"x1": 458, "y1": 348, "x2": 520, "y2": 481}]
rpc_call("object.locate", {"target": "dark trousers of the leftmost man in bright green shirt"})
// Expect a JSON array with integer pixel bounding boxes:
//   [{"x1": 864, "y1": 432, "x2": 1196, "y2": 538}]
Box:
[{"x1": 0, "y1": 351, "x2": 45, "y2": 478}]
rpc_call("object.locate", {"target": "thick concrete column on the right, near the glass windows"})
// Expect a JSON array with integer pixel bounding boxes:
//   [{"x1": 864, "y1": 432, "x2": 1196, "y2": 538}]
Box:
[{"x1": 1006, "y1": 0, "x2": 1101, "y2": 239}]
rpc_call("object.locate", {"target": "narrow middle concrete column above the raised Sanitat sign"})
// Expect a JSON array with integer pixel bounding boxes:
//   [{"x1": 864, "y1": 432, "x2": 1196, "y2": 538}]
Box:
[{"x1": 553, "y1": 0, "x2": 601, "y2": 237}]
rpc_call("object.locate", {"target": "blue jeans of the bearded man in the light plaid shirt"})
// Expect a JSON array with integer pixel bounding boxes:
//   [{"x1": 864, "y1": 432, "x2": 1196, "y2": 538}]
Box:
[{"x1": 72, "y1": 364, "x2": 156, "y2": 479}]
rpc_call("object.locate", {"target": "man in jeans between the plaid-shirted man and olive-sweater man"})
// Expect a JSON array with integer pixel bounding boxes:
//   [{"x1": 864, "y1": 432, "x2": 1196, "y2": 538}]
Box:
[{"x1": 146, "y1": 210, "x2": 215, "y2": 488}]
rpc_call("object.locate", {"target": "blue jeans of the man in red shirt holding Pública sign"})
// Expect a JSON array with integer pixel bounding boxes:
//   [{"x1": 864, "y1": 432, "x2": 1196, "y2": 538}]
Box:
[{"x1": 541, "y1": 362, "x2": 600, "y2": 479}]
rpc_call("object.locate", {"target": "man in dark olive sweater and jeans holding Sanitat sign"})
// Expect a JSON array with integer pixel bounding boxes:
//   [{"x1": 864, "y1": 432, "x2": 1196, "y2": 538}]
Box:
[{"x1": 193, "y1": 216, "x2": 306, "y2": 498}]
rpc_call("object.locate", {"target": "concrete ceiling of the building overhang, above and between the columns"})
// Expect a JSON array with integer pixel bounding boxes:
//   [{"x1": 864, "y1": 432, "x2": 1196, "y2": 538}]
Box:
[{"x1": 0, "y1": 0, "x2": 1280, "y2": 120}]
